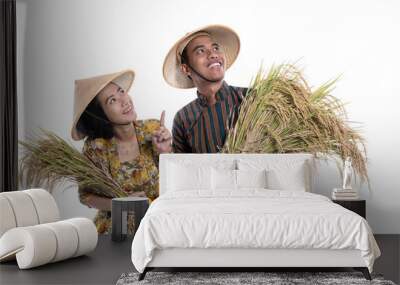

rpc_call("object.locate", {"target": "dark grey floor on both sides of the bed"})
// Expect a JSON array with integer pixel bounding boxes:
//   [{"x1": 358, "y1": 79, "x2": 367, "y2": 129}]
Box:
[{"x1": 0, "y1": 235, "x2": 400, "y2": 285}]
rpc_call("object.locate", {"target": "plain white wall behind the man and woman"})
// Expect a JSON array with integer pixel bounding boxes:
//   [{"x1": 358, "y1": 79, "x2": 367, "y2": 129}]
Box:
[{"x1": 17, "y1": 0, "x2": 400, "y2": 233}]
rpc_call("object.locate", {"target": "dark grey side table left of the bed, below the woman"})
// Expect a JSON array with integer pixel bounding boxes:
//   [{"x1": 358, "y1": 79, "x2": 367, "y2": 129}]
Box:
[{"x1": 111, "y1": 197, "x2": 149, "y2": 241}]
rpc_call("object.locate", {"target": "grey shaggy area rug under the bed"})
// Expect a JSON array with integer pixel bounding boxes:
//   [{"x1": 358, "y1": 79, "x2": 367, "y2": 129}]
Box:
[{"x1": 116, "y1": 272, "x2": 396, "y2": 285}]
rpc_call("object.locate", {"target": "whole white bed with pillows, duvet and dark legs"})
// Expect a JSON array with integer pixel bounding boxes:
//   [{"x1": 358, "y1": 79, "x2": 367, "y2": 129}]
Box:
[{"x1": 132, "y1": 154, "x2": 380, "y2": 280}]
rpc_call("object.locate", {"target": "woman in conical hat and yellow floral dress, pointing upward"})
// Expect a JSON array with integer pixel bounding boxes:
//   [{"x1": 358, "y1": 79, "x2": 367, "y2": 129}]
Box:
[{"x1": 71, "y1": 70, "x2": 171, "y2": 233}]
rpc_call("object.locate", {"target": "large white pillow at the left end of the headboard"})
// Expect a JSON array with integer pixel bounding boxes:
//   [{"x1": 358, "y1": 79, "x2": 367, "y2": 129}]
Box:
[{"x1": 167, "y1": 162, "x2": 211, "y2": 191}]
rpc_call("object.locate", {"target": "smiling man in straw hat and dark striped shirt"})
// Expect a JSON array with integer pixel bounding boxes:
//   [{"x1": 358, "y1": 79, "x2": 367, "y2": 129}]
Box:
[{"x1": 163, "y1": 25, "x2": 247, "y2": 153}]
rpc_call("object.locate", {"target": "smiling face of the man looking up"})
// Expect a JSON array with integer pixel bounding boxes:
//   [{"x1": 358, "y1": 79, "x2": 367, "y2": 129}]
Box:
[{"x1": 182, "y1": 36, "x2": 226, "y2": 83}]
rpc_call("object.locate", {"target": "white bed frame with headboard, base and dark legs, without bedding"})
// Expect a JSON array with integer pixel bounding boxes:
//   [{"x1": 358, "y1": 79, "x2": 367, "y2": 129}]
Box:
[{"x1": 139, "y1": 154, "x2": 371, "y2": 280}]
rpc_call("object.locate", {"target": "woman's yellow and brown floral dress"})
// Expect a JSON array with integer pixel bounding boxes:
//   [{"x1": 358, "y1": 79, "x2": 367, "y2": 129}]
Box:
[{"x1": 79, "y1": 119, "x2": 160, "y2": 234}]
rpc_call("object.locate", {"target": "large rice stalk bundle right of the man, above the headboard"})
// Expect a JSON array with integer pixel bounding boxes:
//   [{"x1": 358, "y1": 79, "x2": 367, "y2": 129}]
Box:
[{"x1": 222, "y1": 64, "x2": 368, "y2": 181}]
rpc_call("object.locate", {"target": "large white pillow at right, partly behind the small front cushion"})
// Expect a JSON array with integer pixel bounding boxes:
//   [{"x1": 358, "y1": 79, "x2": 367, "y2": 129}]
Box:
[{"x1": 238, "y1": 159, "x2": 311, "y2": 192}]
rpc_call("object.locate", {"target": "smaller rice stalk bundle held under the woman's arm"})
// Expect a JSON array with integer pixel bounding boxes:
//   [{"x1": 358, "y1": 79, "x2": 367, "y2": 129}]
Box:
[{"x1": 19, "y1": 130, "x2": 127, "y2": 198}]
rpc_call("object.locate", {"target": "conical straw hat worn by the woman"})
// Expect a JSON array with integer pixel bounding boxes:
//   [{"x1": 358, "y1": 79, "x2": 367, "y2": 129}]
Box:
[{"x1": 71, "y1": 69, "x2": 135, "y2": 141}]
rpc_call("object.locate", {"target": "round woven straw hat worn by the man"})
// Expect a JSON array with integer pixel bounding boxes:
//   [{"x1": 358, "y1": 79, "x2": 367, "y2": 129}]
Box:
[{"x1": 163, "y1": 25, "x2": 240, "y2": 89}]
